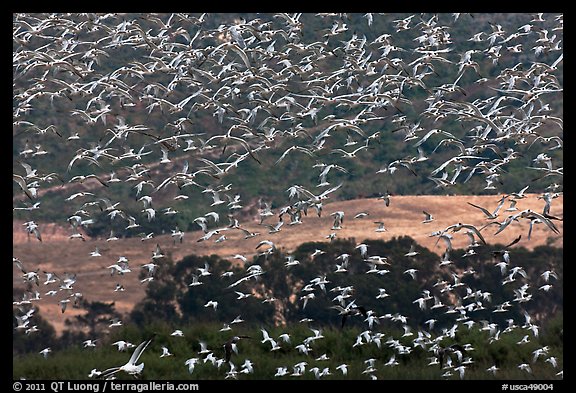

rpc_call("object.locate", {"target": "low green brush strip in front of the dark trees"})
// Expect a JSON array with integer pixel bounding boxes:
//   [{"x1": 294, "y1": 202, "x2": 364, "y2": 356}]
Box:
[{"x1": 13, "y1": 315, "x2": 563, "y2": 380}]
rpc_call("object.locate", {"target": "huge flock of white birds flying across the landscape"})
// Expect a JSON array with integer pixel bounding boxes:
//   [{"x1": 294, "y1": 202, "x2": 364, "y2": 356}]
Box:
[{"x1": 13, "y1": 13, "x2": 563, "y2": 379}]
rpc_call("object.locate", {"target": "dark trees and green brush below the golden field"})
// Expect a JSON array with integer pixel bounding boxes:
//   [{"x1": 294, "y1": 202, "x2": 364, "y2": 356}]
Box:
[{"x1": 13, "y1": 237, "x2": 563, "y2": 380}]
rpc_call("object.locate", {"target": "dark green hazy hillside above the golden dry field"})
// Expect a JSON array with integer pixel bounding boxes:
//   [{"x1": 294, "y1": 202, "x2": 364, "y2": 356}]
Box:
[{"x1": 13, "y1": 13, "x2": 563, "y2": 233}]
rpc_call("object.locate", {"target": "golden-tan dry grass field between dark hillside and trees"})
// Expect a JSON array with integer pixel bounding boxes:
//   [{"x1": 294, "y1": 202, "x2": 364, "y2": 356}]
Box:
[{"x1": 13, "y1": 194, "x2": 564, "y2": 332}]
